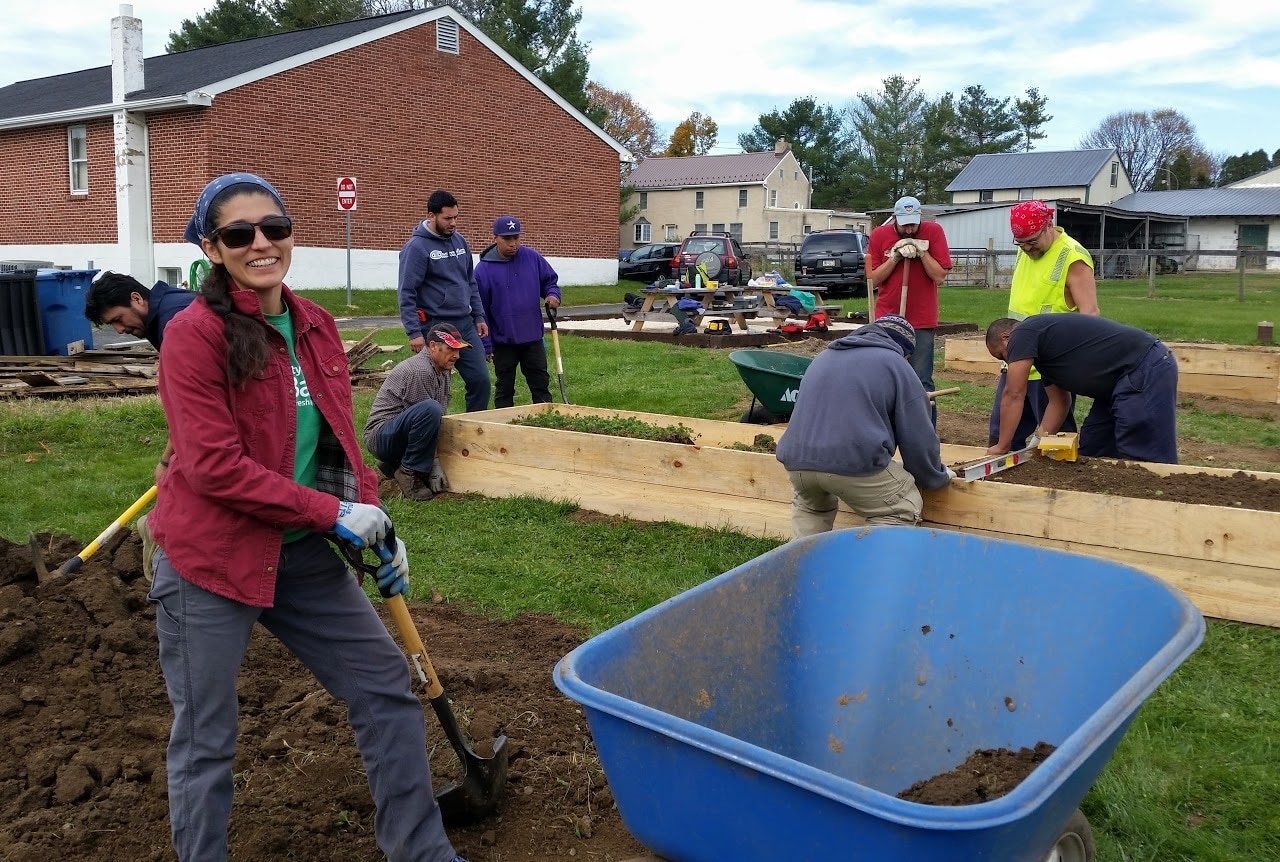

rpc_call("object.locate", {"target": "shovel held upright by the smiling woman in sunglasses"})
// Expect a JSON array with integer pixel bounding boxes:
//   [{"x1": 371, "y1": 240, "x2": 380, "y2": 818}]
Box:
[{"x1": 330, "y1": 528, "x2": 508, "y2": 825}]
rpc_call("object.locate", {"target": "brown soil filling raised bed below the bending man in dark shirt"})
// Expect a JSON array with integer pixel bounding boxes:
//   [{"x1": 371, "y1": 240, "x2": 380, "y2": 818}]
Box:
[{"x1": 982, "y1": 459, "x2": 1280, "y2": 512}]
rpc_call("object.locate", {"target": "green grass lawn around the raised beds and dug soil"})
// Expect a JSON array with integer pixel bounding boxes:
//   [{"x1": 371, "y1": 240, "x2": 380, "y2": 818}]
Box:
[{"x1": 0, "y1": 277, "x2": 1280, "y2": 862}]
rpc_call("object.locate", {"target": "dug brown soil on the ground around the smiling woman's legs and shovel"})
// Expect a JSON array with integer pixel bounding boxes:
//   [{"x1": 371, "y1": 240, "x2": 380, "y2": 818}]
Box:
[{"x1": 0, "y1": 534, "x2": 645, "y2": 862}]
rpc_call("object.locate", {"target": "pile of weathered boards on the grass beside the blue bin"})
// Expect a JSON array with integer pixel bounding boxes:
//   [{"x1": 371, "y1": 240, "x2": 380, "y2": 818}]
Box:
[{"x1": 0, "y1": 334, "x2": 398, "y2": 398}]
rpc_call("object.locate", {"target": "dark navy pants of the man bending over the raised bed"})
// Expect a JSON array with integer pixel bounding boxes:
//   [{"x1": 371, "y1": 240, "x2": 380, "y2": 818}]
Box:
[{"x1": 1080, "y1": 341, "x2": 1178, "y2": 464}]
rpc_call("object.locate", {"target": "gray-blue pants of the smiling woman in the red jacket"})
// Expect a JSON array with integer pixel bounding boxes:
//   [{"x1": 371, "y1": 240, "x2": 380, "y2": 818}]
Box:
[{"x1": 147, "y1": 535, "x2": 454, "y2": 862}]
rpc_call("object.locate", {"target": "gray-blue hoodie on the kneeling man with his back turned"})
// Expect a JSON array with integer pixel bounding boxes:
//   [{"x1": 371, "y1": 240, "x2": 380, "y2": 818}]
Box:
[{"x1": 778, "y1": 324, "x2": 947, "y2": 489}]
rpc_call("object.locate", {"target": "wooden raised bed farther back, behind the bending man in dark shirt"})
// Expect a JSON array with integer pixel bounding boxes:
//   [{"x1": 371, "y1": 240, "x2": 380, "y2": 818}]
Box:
[{"x1": 943, "y1": 338, "x2": 1280, "y2": 403}]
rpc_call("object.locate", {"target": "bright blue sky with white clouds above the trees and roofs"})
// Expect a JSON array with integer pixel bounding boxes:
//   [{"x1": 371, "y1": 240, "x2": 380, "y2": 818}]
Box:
[{"x1": 0, "y1": 0, "x2": 1280, "y2": 156}]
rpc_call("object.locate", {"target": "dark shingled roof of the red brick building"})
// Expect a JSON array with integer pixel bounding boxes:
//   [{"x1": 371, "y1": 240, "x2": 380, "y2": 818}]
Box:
[{"x1": 0, "y1": 9, "x2": 422, "y2": 119}]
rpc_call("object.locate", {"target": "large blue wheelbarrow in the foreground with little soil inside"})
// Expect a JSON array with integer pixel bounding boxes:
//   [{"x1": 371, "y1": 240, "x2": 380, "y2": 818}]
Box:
[{"x1": 554, "y1": 526, "x2": 1204, "y2": 862}]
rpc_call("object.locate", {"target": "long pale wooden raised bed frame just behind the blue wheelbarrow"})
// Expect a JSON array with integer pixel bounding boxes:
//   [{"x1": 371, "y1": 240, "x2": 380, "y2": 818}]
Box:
[{"x1": 440, "y1": 405, "x2": 1280, "y2": 626}]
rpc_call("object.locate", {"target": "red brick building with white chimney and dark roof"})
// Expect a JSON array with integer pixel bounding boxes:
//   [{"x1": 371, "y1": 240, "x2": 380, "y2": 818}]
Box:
[{"x1": 0, "y1": 5, "x2": 630, "y2": 288}]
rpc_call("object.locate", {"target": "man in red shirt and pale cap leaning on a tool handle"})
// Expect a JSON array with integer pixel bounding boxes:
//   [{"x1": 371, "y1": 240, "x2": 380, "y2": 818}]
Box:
[{"x1": 867, "y1": 197, "x2": 951, "y2": 425}]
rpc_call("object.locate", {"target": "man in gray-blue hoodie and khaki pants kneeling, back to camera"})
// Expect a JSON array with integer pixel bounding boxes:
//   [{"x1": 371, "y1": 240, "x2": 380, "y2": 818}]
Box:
[{"x1": 777, "y1": 314, "x2": 955, "y2": 539}]
